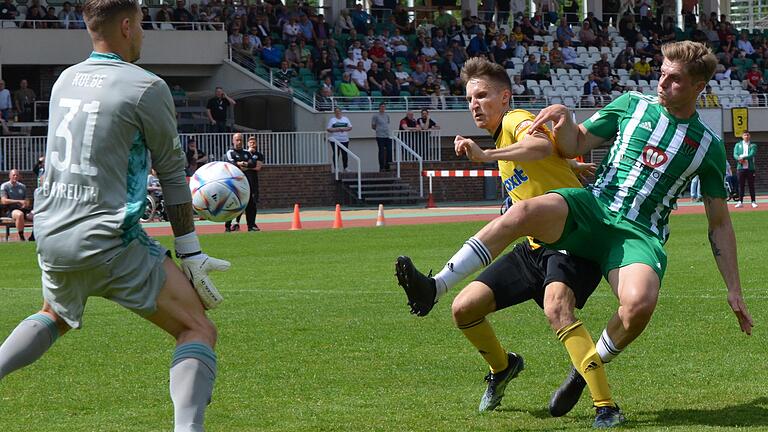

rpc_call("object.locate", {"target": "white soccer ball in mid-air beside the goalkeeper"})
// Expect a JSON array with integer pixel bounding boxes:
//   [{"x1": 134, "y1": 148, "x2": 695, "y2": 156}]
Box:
[{"x1": 189, "y1": 162, "x2": 251, "y2": 222}]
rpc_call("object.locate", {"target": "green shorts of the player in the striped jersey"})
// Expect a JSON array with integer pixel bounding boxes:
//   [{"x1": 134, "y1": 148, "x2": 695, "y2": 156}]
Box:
[{"x1": 547, "y1": 188, "x2": 667, "y2": 283}]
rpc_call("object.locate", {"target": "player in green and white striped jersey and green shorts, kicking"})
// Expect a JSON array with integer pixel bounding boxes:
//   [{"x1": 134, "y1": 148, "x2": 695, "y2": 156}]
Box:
[{"x1": 392, "y1": 41, "x2": 752, "y2": 413}]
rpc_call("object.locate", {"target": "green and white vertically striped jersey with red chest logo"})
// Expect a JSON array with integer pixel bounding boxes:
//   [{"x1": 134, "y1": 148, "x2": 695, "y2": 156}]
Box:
[{"x1": 583, "y1": 92, "x2": 727, "y2": 243}]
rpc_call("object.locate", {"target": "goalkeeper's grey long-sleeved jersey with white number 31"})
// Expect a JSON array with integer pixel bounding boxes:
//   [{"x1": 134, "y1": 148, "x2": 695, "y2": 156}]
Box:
[{"x1": 34, "y1": 52, "x2": 191, "y2": 271}]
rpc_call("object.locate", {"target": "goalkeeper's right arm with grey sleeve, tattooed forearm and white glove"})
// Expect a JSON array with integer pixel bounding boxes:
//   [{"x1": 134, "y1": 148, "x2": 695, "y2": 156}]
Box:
[{"x1": 136, "y1": 80, "x2": 229, "y2": 309}]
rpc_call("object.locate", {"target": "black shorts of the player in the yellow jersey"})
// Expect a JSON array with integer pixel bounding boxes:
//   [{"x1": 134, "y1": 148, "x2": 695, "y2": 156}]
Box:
[{"x1": 475, "y1": 241, "x2": 602, "y2": 310}]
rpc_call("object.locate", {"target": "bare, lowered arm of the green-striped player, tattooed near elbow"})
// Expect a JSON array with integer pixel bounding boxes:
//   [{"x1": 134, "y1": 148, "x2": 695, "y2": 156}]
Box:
[{"x1": 704, "y1": 196, "x2": 753, "y2": 335}]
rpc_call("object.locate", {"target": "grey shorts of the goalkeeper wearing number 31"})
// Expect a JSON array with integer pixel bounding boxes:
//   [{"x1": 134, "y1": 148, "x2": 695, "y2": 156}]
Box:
[{"x1": 41, "y1": 234, "x2": 168, "y2": 328}]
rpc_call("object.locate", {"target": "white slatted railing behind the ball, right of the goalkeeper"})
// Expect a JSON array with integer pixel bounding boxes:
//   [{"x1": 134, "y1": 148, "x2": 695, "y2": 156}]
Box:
[{"x1": 179, "y1": 132, "x2": 330, "y2": 165}]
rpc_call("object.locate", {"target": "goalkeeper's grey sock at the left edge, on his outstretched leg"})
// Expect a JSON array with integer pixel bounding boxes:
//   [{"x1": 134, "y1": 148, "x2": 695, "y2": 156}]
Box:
[{"x1": 0, "y1": 313, "x2": 59, "y2": 379}]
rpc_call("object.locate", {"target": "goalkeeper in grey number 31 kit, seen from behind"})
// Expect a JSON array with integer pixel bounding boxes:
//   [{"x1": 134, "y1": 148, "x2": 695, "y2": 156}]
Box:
[{"x1": 0, "y1": 0, "x2": 229, "y2": 432}]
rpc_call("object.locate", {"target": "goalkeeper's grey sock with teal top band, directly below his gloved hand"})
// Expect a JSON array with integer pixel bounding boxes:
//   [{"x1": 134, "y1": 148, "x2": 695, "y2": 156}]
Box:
[{"x1": 171, "y1": 342, "x2": 216, "y2": 432}]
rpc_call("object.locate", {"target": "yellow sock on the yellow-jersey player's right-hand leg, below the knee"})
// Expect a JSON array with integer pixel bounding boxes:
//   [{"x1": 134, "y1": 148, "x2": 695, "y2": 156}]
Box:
[{"x1": 557, "y1": 321, "x2": 614, "y2": 407}]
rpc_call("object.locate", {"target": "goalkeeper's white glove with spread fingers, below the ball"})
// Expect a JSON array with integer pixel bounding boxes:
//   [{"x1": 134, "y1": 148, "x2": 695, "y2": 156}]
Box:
[{"x1": 174, "y1": 232, "x2": 230, "y2": 309}]
